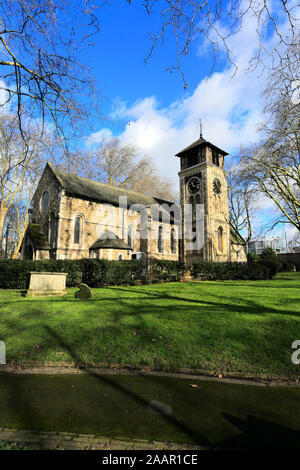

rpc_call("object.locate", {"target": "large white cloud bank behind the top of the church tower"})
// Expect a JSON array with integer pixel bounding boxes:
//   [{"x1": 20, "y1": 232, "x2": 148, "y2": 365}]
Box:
[{"x1": 89, "y1": 61, "x2": 261, "y2": 188}]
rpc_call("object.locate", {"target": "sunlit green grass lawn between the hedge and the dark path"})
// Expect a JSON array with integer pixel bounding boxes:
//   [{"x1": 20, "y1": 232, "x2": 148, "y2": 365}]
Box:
[{"x1": 0, "y1": 273, "x2": 300, "y2": 378}]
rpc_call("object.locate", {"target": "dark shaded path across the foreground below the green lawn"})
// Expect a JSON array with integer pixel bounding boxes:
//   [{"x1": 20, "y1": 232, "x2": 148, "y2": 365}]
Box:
[{"x1": 0, "y1": 370, "x2": 300, "y2": 449}]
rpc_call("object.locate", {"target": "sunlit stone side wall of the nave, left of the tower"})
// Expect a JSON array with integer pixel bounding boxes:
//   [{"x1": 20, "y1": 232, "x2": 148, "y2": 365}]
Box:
[{"x1": 57, "y1": 187, "x2": 179, "y2": 260}]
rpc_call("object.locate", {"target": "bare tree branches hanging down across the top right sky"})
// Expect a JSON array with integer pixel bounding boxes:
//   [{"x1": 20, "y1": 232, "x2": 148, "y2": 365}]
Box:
[{"x1": 140, "y1": 0, "x2": 298, "y2": 88}]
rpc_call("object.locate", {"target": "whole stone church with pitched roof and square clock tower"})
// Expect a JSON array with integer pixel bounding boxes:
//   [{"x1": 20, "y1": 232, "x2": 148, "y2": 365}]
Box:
[{"x1": 20, "y1": 136, "x2": 246, "y2": 264}]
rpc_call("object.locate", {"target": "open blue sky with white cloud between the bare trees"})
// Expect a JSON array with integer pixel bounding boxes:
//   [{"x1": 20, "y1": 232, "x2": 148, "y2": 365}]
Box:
[{"x1": 72, "y1": 0, "x2": 298, "y2": 242}]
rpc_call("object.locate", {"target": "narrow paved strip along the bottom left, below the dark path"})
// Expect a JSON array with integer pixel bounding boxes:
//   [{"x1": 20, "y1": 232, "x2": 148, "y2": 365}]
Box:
[{"x1": 0, "y1": 428, "x2": 204, "y2": 450}]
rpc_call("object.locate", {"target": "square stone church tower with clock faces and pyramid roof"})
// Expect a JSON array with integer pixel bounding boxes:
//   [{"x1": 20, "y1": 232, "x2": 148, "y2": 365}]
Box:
[{"x1": 176, "y1": 130, "x2": 230, "y2": 265}]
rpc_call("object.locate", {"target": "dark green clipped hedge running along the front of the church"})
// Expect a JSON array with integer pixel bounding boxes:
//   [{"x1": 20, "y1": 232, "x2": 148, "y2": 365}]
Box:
[{"x1": 0, "y1": 252, "x2": 280, "y2": 289}]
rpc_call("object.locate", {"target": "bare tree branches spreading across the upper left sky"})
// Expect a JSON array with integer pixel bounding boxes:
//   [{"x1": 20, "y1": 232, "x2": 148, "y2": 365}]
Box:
[{"x1": 0, "y1": 0, "x2": 98, "y2": 142}]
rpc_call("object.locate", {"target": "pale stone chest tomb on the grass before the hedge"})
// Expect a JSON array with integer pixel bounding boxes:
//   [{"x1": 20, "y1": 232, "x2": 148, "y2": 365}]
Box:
[{"x1": 26, "y1": 271, "x2": 68, "y2": 296}]
